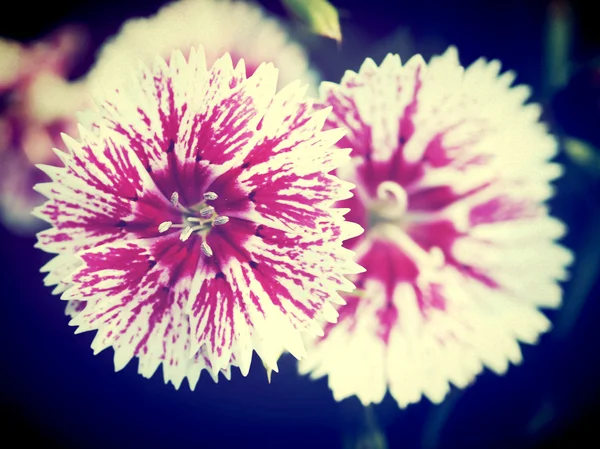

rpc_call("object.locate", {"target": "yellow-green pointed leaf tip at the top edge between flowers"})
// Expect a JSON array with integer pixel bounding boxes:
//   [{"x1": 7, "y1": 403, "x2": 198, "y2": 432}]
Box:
[{"x1": 281, "y1": 0, "x2": 342, "y2": 44}]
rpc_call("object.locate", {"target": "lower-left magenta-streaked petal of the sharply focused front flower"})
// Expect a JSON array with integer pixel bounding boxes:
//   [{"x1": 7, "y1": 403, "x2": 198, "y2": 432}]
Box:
[{"x1": 63, "y1": 236, "x2": 212, "y2": 388}]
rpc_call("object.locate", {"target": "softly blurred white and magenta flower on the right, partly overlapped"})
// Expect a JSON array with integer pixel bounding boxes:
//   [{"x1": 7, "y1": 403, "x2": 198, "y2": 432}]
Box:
[{"x1": 300, "y1": 47, "x2": 572, "y2": 407}]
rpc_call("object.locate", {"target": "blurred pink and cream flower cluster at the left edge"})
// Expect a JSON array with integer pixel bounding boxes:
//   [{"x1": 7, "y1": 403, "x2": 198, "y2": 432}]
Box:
[{"x1": 0, "y1": 27, "x2": 88, "y2": 234}]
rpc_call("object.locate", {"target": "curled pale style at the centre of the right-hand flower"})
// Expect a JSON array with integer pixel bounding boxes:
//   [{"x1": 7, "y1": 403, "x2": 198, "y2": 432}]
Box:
[{"x1": 369, "y1": 181, "x2": 408, "y2": 227}]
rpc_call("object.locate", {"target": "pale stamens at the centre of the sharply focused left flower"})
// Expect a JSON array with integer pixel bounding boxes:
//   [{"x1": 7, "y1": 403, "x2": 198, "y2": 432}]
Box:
[{"x1": 158, "y1": 192, "x2": 229, "y2": 257}]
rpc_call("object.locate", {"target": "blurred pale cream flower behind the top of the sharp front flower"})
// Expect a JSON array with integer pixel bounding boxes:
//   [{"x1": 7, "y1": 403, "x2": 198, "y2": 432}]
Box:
[{"x1": 88, "y1": 0, "x2": 318, "y2": 96}]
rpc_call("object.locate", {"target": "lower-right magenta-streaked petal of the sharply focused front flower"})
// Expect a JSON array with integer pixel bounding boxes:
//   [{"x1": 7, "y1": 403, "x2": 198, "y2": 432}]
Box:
[{"x1": 189, "y1": 220, "x2": 357, "y2": 369}]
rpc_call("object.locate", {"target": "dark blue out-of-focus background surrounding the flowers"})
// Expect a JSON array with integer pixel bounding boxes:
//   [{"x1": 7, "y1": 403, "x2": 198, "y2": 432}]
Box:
[{"x1": 0, "y1": 0, "x2": 600, "y2": 449}]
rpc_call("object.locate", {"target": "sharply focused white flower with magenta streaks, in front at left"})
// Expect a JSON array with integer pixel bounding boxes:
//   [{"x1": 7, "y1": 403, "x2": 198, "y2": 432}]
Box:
[{"x1": 36, "y1": 50, "x2": 362, "y2": 388}]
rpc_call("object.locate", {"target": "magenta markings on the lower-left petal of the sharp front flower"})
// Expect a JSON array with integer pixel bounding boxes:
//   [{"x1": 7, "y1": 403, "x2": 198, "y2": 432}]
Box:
[{"x1": 73, "y1": 238, "x2": 200, "y2": 359}]
